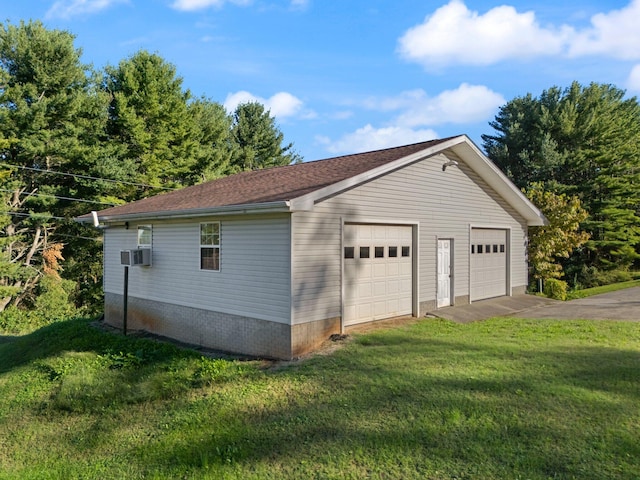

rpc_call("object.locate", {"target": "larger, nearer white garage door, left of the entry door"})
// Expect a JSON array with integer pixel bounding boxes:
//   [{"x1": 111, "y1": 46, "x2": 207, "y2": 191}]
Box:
[{"x1": 343, "y1": 224, "x2": 413, "y2": 325}]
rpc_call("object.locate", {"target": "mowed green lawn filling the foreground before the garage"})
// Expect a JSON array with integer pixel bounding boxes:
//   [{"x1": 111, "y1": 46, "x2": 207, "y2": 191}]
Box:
[{"x1": 0, "y1": 318, "x2": 640, "y2": 479}]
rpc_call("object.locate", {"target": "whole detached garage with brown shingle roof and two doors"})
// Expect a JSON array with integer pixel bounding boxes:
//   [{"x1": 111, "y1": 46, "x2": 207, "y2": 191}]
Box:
[{"x1": 78, "y1": 135, "x2": 545, "y2": 358}]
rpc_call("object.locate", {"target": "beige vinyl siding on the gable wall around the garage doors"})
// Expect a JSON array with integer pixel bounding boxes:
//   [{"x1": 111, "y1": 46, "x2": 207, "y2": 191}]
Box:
[{"x1": 292, "y1": 154, "x2": 527, "y2": 323}]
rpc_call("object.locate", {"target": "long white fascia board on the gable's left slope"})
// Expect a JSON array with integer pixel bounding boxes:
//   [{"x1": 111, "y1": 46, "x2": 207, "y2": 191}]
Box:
[{"x1": 291, "y1": 135, "x2": 469, "y2": 211}]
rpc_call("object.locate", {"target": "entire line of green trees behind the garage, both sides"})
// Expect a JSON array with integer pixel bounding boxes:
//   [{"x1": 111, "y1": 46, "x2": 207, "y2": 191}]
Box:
[{"x1": 0, "y1": 21, "x2": 640, "y2": 322}]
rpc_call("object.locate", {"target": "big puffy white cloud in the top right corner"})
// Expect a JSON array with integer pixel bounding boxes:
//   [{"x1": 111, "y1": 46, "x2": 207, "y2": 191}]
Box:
[{"x1": 398, "y1": 0, "x2": 640, "y2": 69}]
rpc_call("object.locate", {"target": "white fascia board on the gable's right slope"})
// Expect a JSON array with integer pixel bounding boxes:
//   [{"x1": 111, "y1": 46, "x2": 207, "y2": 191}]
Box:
[{"x1": 452, "y1": 138, "x2": 549, "y2": 227}]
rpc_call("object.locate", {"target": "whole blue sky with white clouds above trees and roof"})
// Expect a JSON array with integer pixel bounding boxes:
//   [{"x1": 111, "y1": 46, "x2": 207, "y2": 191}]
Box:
[{"x1": 5, "y1": 0, "x2": 640, "y2": 160}]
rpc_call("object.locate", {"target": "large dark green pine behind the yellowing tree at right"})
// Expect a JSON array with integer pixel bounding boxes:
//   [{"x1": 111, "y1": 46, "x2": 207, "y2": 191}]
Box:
[{"x1": 483, "y1": 82, "x2": 640, "y2": 269}]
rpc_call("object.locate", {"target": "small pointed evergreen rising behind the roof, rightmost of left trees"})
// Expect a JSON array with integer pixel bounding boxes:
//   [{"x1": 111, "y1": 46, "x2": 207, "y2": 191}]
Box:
[{"x1": 231, "y1": 102, "x2": 302, "y2": 172}]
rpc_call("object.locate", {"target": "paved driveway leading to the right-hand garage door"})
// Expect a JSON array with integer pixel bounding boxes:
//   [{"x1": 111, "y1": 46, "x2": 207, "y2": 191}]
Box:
[{"x1": 428, "y1": 287, "x2": 640, "y2": 323}]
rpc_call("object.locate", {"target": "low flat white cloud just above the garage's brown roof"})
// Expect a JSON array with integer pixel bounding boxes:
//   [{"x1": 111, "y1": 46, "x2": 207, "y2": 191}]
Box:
[{"x1": 316, "y1": 124, "x2": 438, "y2": 154}]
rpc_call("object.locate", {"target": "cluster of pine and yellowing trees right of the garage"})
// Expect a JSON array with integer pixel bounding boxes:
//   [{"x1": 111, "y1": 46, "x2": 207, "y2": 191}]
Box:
[{"x1": 482, "y1": 82, "x2": 640, "y2": 287}]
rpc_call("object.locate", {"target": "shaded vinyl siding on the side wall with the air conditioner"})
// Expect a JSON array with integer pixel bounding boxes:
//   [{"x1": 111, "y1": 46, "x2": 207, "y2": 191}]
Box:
[{"x1": 105, "y1": 215, "x2": 291, "y2": 323}]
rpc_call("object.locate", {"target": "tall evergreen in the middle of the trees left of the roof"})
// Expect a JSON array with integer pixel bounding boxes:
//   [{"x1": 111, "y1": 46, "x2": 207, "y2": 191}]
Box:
[{"x1": 102, "y1": 50, "x2": 197, "y2": 201}]
